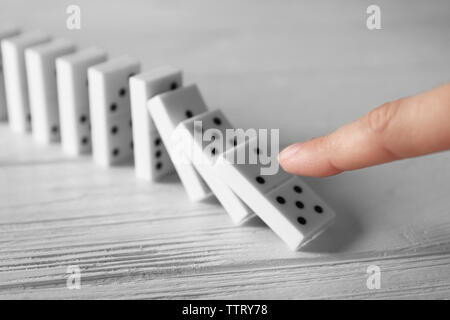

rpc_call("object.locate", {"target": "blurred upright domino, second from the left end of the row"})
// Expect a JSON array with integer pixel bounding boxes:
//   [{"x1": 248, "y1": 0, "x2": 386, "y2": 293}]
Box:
[{"x1": 2, "y1": 31, "x2": 50, "y2": 132}]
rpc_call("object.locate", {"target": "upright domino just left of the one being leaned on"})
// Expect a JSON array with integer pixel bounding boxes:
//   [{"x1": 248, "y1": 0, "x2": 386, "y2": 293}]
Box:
[{"x1": 88, "y1": 56, "x2": 140, "y2": 166}]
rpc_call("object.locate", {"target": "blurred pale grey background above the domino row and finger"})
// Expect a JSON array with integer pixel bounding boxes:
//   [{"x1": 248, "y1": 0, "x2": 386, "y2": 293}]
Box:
[{"x1": 0, "y1": 0, "x2": 450, "y2": 142}]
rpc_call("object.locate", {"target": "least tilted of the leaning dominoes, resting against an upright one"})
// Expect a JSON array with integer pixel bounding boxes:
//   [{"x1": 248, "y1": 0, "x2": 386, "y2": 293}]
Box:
[{"x1": 147, "y1": 85, "x2": 211, "y2": 201}]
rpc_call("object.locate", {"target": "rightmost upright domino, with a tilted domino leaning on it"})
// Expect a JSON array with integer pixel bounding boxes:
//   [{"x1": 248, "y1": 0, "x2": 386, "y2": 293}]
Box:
[{"x1": 130, "y1": 66, "x2": 182, "y2": 181}]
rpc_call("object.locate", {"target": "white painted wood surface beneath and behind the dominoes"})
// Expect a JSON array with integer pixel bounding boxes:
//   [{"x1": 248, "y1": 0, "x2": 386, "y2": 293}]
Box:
[{"x1": 0, "y1": 0, "x2": 450, "y2": 299}]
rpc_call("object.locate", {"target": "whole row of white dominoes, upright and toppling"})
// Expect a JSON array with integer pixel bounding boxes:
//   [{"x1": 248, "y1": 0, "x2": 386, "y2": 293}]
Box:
[{"x1": 0, "y1": 26, "x2": 335, "y2": 250}]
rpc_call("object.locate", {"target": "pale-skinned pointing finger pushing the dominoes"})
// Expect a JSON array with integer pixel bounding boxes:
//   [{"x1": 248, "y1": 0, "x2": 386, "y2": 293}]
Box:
[{"x1": 279, "y1": 83, "x2": 450, "y2": 177}]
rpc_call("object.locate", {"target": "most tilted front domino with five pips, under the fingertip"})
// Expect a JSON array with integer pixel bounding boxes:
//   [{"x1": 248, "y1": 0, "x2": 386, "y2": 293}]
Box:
[{"x1": 215, "y1": 139, "x2": 335, "y2": 250}]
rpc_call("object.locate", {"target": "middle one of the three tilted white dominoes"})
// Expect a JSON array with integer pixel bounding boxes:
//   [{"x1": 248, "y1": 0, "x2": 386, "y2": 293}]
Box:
[{"x1": 174, "y1": 110, "x2": 254, "y2": 224}]
